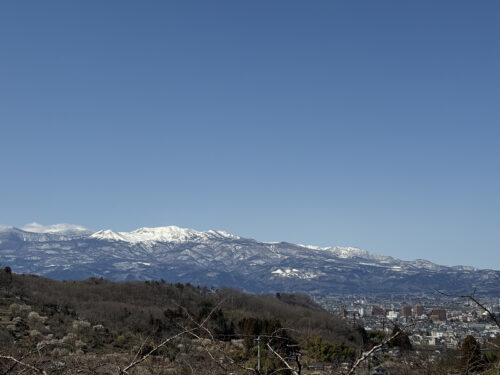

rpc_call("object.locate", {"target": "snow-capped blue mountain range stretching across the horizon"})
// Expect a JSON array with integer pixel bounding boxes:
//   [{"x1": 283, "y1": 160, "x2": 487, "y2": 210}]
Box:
[{"x1": 0, "y1": 223, "x2": 500, "y2": 295}]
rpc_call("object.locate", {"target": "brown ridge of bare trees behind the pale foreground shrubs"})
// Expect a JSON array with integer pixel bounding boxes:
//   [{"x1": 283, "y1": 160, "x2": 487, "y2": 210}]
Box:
[{"x1": 4, "y1": 275, "x2": 362, "y2": 344}]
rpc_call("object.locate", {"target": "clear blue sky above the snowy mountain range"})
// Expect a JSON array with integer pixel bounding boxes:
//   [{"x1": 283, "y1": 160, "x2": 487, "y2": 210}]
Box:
[{"x1": 0, "y1": 0, "x2": 500, "y2": 269}]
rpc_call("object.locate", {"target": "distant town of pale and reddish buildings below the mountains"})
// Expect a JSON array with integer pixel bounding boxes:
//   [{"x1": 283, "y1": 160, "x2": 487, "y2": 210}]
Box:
[{"x1": 317, "y1": 295, "x2": 500, "y2": 349}]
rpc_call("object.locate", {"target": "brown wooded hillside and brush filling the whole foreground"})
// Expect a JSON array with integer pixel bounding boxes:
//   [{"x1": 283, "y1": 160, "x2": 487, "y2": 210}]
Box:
[{"x1": 0, "y1": 268, "x2": 499, "y2": 375}]
